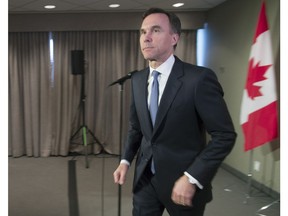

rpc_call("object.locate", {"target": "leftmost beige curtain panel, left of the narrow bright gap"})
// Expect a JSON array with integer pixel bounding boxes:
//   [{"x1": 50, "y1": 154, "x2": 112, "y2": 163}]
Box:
[{"x1": 8, "y1": 33, "x2": 51, "y2": 157}]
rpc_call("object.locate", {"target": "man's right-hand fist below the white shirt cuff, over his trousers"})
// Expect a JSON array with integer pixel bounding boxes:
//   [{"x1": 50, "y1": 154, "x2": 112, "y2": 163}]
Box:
[{"x1": 171, "y1": 175, "x2": 196, "y2": 206}]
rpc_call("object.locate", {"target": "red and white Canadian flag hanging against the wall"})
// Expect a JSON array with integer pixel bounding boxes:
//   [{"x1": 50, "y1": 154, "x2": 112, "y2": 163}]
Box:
[{"x1": 240, "y1": 2, "x2": 278, "y2": 151}]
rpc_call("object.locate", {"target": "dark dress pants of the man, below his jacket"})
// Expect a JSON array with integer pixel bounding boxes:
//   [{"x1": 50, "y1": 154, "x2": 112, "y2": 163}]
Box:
[{"x1": 133, "y1": 166, "x2": 206, "y2": 216}]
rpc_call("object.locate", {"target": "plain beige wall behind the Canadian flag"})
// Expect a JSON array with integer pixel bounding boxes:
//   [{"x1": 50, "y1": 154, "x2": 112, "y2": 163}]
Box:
[{"x1": 206, "y1": 0, "x2": 280, "y2": 192}]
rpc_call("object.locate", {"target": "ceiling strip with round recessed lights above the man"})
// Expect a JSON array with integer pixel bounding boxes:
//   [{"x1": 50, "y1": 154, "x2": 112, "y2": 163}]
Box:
[{"x1": 8, "y1": 0, "x2": 226, "y2": 13}]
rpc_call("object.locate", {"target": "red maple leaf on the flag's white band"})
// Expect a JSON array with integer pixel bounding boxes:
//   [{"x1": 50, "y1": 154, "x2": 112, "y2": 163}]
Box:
[{"x1": 245, "y1": 58, "x2": 271, "y2": 100}]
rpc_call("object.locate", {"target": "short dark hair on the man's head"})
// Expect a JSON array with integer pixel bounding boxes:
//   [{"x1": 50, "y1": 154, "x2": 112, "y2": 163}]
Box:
[{"x1": 142, "y1": 8, "x2": 181, "y2": 37}]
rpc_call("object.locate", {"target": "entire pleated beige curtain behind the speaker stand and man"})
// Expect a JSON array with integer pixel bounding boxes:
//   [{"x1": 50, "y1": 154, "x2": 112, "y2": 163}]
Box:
[{"x1": 9, "y1": 31, "x2": 196, "y2": 157}]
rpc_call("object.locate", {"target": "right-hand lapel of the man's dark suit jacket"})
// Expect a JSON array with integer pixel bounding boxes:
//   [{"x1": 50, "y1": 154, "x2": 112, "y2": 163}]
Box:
[{"x1": 153, "y1": 57, "x2": 183, "y2": 133}]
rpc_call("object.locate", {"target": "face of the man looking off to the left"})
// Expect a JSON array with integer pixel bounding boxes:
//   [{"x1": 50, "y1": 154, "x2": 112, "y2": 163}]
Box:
[{"x1": 140, "y1": 13, "x2": 179, "y2": 63}]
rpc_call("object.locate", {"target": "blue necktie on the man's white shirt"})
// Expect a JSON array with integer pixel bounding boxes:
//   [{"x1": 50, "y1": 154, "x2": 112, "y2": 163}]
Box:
[{"x1": 150, "y1": 71, "x2": 160, "y2": 174}]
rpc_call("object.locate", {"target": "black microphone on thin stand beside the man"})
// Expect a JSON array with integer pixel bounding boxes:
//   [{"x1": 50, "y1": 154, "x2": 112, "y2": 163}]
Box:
[{"x1": 109, "y1": 70, "x2": 137, "y2": 216}]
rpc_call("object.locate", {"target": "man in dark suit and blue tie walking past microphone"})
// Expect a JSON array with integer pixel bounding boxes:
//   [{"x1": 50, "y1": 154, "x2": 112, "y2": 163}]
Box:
[{"x1": 113, "y1": 8, "x2": 236, "y2": 216}]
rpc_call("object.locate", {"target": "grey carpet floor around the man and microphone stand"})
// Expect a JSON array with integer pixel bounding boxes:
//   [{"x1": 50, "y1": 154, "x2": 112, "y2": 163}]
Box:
[{"x1": 8, "y1": 155, "x2": 280, "y2": 216}]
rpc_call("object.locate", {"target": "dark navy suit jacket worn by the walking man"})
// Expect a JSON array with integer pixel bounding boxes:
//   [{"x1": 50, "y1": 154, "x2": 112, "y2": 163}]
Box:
[{"x1": 122, "y1": 57, "x2": 236, "y2": 204}]
